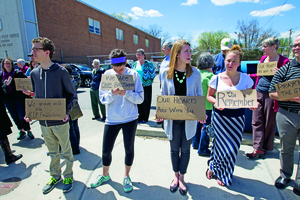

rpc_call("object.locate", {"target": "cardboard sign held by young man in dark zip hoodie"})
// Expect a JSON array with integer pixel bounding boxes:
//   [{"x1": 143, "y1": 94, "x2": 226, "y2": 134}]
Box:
[{"x1": 25, "y1": 98, "x2": 66, "y2": 120}]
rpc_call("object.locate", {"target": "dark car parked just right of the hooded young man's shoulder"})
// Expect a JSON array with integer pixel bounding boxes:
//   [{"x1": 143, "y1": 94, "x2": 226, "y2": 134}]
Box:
[{"x1": 69, "y1": 63, "x2": 92, "y2": 87}]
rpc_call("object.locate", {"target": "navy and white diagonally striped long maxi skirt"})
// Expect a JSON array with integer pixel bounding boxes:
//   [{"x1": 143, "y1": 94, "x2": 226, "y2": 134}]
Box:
[{"x1": 208, "y1": 108, "x2": 245, "y2": 186}]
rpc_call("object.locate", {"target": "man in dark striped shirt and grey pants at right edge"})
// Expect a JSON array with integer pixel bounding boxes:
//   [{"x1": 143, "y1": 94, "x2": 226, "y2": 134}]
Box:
[{"x1": 269, "y1": 35, "x2": 300, "y2": 196}]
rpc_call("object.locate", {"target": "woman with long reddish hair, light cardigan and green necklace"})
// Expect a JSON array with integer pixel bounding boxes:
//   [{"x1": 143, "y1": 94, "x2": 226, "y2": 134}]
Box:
[{"x1": 161, "y1": 40, "x2": 205, "y2": 195}]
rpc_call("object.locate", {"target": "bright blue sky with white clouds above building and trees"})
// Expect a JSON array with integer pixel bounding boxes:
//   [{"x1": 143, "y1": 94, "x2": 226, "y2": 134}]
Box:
[{"x1": 81, "y1": 0, "x2": 300, "y2": 47}]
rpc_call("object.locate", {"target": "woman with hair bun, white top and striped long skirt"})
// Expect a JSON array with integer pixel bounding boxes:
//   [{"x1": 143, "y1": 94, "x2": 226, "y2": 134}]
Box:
[{"x1": 206, "y1": 45, "x2": 255, "y2": 186}]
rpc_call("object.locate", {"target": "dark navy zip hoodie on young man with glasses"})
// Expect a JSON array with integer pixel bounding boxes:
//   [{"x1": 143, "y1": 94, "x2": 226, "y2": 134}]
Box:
[{"x1": 30, "y1": 63, "x2": 77, "y2": 126}]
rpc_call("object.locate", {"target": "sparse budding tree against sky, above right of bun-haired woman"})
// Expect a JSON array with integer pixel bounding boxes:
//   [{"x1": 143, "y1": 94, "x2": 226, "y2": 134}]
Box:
[{"x1": 237, "y1": 19, "x2": 276, "y2": 50}]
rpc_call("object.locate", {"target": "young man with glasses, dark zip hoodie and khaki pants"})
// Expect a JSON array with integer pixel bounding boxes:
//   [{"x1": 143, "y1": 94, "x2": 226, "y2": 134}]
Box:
[{"x1": 27, "y1": 37, "x2": 77, "y2": 194}]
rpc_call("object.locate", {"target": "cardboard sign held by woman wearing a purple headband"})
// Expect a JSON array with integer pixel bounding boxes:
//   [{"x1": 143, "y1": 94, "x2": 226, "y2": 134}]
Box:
[{"x1": 100, "y1": 74, "x2": 134, "y2": 90}]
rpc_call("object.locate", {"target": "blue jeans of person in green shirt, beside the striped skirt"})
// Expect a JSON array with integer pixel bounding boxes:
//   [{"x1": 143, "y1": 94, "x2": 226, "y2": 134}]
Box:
[{"x1": 192, "y1": 110, "x2": 212, "y2": 154}]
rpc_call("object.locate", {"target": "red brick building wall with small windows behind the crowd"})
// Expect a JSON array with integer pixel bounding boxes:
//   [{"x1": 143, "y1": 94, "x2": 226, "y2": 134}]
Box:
[{"x1": 35, "y1": 0, "x2": 161, "y2": 64}]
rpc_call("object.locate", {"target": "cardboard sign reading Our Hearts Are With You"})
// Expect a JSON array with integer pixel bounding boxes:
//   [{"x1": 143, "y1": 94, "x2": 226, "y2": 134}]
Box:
[{"x1": 156, "y1": 95, "x2": 206, "y2": 120}]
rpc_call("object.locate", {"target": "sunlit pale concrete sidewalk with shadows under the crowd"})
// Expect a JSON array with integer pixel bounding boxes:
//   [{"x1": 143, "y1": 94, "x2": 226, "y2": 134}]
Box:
[{"x1": 0, "y1": 88, "x2": 299, "y2": 200}]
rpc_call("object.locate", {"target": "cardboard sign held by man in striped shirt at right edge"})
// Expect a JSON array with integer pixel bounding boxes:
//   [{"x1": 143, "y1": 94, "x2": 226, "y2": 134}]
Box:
[{"x1": 275, "y1": 79, "x2": 300, "y2": 101}]
